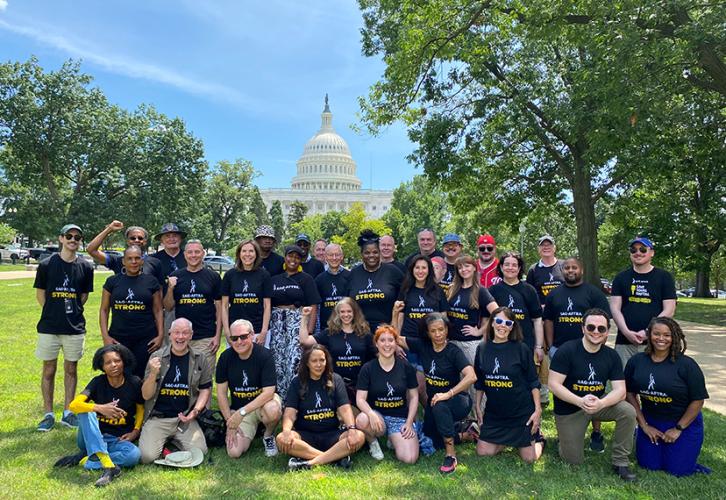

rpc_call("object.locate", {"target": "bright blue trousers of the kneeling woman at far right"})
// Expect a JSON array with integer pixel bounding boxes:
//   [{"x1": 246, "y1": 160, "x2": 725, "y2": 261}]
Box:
[{"x1": 635, "y1": 413, "x2": 710, "y2": 476}]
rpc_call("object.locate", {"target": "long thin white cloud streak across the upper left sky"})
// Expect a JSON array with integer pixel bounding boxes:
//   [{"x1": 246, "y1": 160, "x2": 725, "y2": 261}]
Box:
[{"x1": 0, "y1": 18, "x2": 258, "y2": 110}]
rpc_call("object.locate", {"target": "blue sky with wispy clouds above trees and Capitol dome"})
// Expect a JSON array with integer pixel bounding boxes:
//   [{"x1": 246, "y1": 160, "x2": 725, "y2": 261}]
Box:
[{"x1": 0, "y1": 0, "x2": 420, "y2": 189}]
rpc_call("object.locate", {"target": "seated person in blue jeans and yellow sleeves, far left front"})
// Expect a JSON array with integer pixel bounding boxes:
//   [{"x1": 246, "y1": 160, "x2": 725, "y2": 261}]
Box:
[{"x1": 55, "y1": 344, "x2": 144, "y2": 487}]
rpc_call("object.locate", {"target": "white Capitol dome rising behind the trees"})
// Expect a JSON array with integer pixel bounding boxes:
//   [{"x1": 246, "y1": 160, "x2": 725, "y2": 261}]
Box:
[{"x1": 292, "y1": 94, "x2": 361, "y2": 191}]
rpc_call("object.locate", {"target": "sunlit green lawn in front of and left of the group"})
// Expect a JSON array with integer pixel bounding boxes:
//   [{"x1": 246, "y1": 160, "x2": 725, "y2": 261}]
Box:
[{"x1": 0, "y1": 276, "x2": 726, "y2": 499}]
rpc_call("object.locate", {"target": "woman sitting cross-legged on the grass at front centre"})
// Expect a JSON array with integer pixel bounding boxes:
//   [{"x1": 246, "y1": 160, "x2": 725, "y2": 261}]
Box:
[{"x1": 277, "y1": 344, "x2": 365, "y2": 471}]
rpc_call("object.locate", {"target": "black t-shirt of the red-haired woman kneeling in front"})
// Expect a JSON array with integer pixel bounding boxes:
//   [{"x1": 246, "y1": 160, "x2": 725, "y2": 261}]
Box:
[{"x1": 356, "y1": 357, "x2": 418, "y2": 418}]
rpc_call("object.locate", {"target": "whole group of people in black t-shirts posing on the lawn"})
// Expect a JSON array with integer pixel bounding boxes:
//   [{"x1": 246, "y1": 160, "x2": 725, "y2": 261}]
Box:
[{"x1": 35, "y1": 221, "x2": 708, "y2": 486}]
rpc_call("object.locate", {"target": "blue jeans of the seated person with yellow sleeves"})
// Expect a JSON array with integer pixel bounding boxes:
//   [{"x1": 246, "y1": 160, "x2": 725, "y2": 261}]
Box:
[{"x1": 76, "y1": 412, "x2": 141, "y2": 470}]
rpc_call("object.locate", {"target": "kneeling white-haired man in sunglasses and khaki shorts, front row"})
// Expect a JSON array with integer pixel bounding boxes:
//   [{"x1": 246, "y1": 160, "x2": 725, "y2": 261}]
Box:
[{"x1": 216, "y1": 319, "x2": 282, "y2": 458}]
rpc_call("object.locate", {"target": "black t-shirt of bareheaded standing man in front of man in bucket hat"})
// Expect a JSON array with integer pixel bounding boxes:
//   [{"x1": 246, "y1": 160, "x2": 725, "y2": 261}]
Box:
[{"x1": 171, "y1": 267, "x2": 222, "y2": 340}]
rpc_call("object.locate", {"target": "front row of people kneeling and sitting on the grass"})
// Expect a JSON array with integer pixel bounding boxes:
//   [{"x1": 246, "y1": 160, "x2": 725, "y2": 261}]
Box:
[{"x1": 56, "y1": 306, "x2": 708, "y2": 486}]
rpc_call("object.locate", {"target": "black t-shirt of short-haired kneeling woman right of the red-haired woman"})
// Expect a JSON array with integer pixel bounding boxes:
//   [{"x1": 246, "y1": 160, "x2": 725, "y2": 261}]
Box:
[{"x1": 406, "y1": 338, "x2": 471, "y2": 400}]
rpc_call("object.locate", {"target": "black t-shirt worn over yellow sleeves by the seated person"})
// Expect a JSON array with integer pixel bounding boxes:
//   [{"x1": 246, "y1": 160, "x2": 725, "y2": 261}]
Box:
[{"x1": 81, "y1": 375, "x2": 144, "y2": 437}]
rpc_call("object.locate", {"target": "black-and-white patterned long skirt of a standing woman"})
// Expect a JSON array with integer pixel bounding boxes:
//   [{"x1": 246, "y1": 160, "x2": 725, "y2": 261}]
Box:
[{"x1": 269, "y1": 307, "x2": 302, "y2": 404}]
